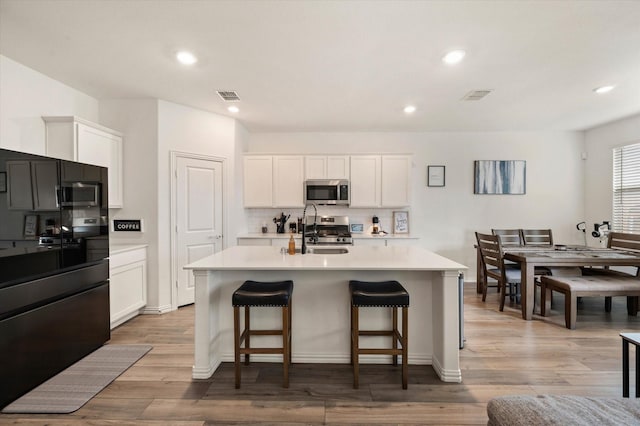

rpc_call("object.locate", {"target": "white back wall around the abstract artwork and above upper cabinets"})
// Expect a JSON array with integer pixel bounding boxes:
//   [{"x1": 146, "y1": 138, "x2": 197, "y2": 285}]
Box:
[{"x1": 248, "y1": 132, "x2": 584, "y2": 274}]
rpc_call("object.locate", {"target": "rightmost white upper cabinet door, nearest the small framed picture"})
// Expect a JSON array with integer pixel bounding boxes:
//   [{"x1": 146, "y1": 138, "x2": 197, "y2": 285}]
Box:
[{"x1": 381, "y1": 155, "x2": 411, "y2": 207}]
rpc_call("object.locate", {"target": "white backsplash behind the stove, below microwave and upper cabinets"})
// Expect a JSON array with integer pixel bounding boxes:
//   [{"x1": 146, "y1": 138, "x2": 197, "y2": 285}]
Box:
[{"x1": 245, "y1": 206, "x2": 402, "y2": 234}]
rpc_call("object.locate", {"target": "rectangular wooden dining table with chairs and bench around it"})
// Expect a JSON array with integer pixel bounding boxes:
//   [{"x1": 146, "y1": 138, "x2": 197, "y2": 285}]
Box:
[{"x1": 503, "y1": 245, "x2": 640, "y2": 320}]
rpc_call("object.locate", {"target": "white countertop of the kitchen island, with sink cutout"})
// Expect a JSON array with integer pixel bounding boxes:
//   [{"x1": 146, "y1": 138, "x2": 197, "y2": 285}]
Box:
[{"x1": 184, "y1": 246, "x2": 467, "y2": 271}]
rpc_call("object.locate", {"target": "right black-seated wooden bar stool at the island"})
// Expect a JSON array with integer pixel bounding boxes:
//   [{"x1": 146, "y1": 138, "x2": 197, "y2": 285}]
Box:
[{"x1": 349, "y1": 280, "x2": 409, "y2": 389}]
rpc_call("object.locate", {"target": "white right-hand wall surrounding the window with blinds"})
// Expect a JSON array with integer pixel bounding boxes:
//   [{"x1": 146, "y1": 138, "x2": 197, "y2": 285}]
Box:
[{"x1": 584, "y1": 114, "x2": 640, "y2": 231}]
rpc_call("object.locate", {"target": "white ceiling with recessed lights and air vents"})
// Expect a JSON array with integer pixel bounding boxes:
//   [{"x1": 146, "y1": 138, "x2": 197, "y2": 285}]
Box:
[{"x1": 0, "y1": 0, "x2": 640, "y2": 132}]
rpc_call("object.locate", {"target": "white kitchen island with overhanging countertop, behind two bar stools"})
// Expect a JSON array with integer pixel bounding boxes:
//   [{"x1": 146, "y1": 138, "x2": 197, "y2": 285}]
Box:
[{"x1": 185, "y1": 246, "x2": 466, "y2": 382}]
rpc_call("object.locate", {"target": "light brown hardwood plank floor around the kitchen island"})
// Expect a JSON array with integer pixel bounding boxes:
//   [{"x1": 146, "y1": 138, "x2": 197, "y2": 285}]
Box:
[{"x1": 0, "y1": 284, "x2": 640, "y2": 425}]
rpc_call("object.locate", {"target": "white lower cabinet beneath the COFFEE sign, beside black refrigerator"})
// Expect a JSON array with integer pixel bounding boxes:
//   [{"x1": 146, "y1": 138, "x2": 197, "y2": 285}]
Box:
[{"x1": 109, "y1": 246, "x2": 147, "y2": 329}]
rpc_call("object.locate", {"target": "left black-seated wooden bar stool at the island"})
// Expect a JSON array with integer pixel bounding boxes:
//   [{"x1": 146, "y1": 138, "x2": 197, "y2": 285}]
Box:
[{"x1": 232, "y1": 281, "x2": 293, "y2": 389}]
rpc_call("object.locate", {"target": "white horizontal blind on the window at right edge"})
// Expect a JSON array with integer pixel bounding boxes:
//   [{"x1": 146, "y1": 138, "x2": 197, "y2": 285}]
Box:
[{"x1": 612, "y1": 143, "x2": 640, "y2": 234}]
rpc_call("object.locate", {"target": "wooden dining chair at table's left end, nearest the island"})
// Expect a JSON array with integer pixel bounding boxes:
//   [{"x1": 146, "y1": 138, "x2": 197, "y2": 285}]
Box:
[{"x1": 476, "y1": 232, "x2": 520, "y2": 311}]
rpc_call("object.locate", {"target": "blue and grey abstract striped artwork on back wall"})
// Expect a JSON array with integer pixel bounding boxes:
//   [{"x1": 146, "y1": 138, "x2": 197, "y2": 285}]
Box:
[{"x1": 473, "y1": 160, "x2": 527, "y2": 194}]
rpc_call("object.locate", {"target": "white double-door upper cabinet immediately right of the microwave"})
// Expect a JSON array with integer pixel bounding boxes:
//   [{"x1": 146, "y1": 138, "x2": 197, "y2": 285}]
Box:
[{"x1": 350, "y1": 155, "x2": 411, "y2": 207}]
